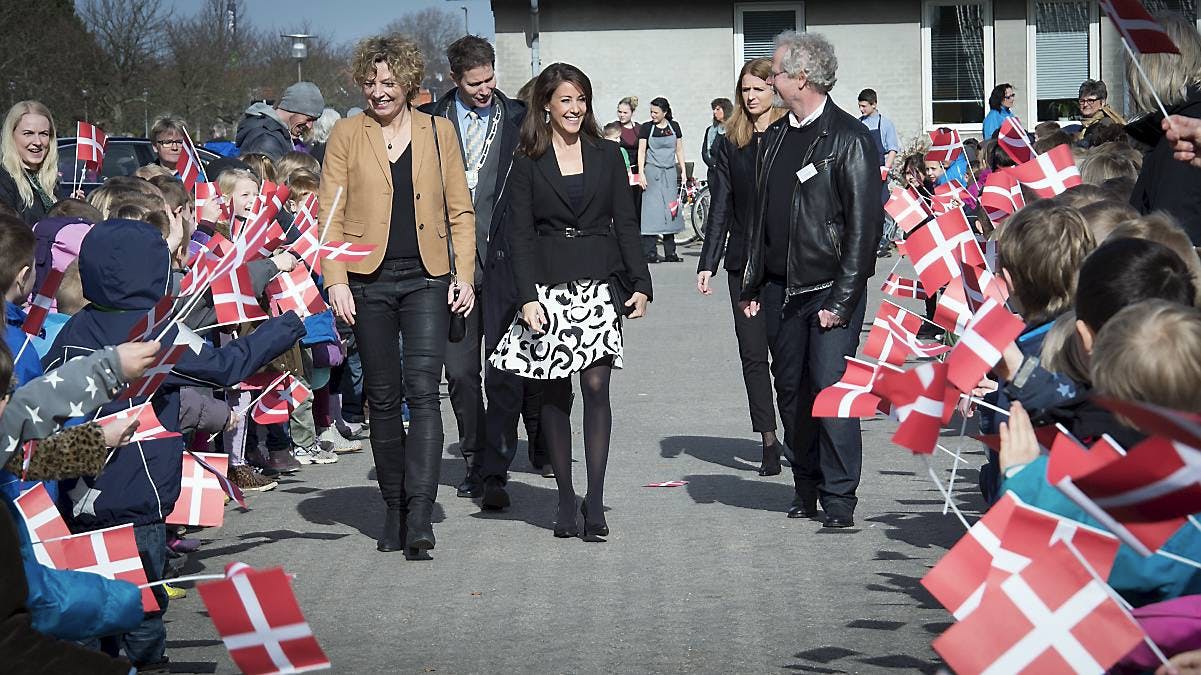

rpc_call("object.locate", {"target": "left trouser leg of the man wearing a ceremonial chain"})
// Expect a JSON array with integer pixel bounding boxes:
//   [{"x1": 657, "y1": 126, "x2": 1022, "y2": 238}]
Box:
[{"x1": 446, "y1": 286, "x2": 486, "y2": 471}]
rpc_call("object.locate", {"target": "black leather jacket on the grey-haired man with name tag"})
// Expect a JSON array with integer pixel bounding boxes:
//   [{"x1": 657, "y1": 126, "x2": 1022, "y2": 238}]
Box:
[{"x1": 742, "y1": 100, "x2": 884, "y2": 319}]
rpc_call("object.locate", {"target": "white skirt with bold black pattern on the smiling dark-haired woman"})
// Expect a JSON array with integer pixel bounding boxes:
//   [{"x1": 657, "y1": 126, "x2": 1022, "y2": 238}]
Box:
[{"x1": 489, "y1": 279, "x2": 622, "y2": 380}]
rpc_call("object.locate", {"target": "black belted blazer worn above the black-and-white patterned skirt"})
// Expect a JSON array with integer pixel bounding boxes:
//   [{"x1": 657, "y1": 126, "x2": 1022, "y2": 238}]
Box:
[{"x1": 507, "y1": 138, "x2": 651, "y2": 306}]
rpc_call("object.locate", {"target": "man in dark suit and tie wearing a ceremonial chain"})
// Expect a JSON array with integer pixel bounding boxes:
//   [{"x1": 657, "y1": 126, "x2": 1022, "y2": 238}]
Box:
[{"x1": 420, "y1": 35, "x2": 537, "y2": 509}]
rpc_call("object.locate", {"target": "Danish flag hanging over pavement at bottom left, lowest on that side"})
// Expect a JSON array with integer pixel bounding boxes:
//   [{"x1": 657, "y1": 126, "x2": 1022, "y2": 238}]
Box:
[{"x1": 196, "y1": 563, "x2": 329, "y2": 675}]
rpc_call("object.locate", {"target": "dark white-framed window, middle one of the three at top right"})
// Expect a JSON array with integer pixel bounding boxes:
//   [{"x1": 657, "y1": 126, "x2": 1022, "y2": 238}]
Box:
[{"x1": 922, "y1": 0, "x2": 992, "y2": 127}]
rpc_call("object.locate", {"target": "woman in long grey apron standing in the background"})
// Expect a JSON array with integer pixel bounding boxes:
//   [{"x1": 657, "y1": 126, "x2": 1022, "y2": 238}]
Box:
[{"x1": 638, "y1": 96, "x2": 683, "y2": 263}]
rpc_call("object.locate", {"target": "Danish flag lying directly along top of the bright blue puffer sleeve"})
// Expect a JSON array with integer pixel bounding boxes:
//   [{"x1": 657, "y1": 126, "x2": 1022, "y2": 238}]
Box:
[{"x1": 42, "y1": 522, "x2": 159, "y2": 611}]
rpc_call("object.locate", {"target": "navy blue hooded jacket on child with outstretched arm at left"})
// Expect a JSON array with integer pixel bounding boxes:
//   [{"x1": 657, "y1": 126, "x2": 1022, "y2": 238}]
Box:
[{"x1": 43, "y1": 220, "x2": 304, "y2": 530}]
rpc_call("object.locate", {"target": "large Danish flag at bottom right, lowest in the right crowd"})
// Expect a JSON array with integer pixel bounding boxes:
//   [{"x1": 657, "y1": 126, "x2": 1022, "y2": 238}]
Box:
[{"x1": 934, "y1": 542, "x2": 1143, "y2": 673}]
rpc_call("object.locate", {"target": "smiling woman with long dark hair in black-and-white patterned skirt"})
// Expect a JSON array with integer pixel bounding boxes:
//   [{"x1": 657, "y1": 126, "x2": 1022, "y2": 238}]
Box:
[{"x1": 491, "y1": 64, "x2": 651, "y2": 540}]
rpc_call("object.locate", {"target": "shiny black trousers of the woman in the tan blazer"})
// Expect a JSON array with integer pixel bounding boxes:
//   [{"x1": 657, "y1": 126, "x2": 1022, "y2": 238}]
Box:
[{"x1": 349, "y1": 259, "x2": 450, "y2": 509}]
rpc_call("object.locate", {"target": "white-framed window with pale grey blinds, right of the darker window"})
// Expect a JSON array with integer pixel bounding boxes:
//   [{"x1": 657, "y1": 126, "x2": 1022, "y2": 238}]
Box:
[{"x1": 1030, "y1": 0, "x2": 1097, "y2": 121}]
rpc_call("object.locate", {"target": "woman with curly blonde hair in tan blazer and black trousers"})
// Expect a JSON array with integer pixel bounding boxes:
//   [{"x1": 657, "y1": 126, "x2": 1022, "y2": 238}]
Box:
[{"x1": 321, "y1": 36, "x2": 476, "y2": 558}]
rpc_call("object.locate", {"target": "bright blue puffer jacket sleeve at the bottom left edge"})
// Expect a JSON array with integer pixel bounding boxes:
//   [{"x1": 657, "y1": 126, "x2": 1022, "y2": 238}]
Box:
[{"x1": 5, "y1": 500, "x2": 142, "y2": 640}]
